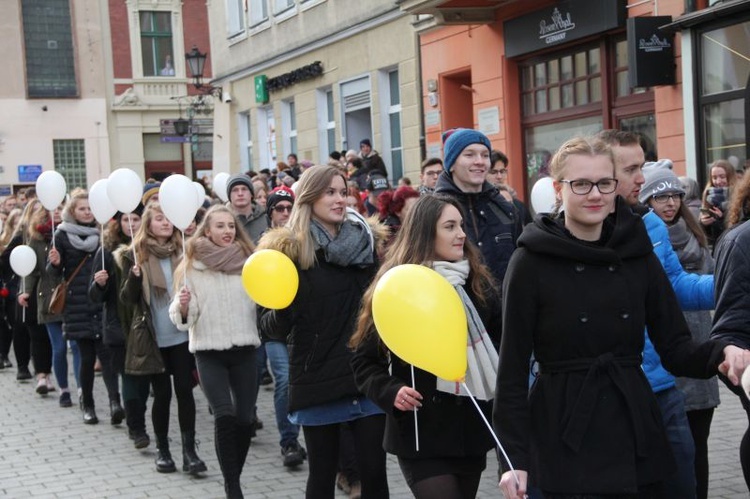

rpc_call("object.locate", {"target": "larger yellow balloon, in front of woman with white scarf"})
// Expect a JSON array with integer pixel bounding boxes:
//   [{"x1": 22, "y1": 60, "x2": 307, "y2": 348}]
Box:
[{"x1": 372, "y1": 264, "x2": 468, "y2": 381}]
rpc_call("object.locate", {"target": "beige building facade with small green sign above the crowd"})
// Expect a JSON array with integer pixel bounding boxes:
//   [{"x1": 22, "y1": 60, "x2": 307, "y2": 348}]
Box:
[{"x1": 209, "y1": 0, "x2": 421, "y2": 182}]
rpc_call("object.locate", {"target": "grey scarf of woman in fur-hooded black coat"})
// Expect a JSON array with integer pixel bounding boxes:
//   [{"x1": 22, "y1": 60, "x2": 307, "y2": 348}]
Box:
[{"x1": 310, "y1": 219, "x2": 375, "y2": 267}]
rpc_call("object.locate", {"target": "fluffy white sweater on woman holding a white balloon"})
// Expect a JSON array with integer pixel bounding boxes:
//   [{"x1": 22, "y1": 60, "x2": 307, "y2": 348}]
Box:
[{"x1": 169, "y1": 260, "x2": 260, "y2": 352}]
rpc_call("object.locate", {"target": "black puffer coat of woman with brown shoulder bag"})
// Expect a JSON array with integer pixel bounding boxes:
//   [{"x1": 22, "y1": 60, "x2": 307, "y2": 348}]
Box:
[{"x1": 47, "y1": 230, "x2": 102, "y2": 340}]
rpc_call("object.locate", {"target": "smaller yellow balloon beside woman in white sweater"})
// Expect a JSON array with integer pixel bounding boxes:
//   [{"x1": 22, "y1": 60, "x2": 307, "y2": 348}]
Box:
[{"x1": 242, "y1": 249, "x2": 299, "y2": 309}]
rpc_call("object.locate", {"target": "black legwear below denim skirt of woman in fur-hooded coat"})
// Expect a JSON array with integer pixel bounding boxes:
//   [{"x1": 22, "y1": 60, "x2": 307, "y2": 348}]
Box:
[{"x1": 302, "y1": 415, "x2": 389, "y2": 499}]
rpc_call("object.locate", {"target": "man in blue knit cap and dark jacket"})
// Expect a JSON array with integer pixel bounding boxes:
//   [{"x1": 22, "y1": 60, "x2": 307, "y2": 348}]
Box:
[{"x1": 435, "y1": 128, "x2": 522, "y2": 284}]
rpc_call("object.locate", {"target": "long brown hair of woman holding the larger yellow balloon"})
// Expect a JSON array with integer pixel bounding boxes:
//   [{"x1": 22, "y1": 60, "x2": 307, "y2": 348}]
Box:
[{"x1": 349, "y1": 194, "x2": 496, "y2": 348}]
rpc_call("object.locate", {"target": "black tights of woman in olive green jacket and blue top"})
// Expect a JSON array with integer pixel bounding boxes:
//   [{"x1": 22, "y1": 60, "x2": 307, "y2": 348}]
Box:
[{"x1": 151, "y1": 341, "x2": 195, "y2": 437}]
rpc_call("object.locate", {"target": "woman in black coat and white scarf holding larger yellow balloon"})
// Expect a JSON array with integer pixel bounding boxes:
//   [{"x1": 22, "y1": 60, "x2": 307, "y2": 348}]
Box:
[{"x1": 351, "y1": 194, "x2": 501, "y2": 499}]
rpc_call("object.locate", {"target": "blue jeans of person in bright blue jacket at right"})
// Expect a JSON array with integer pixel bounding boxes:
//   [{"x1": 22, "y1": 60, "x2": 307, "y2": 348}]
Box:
[{"x1": 655, "y1": 387, "x2": 695, "y2": 499}]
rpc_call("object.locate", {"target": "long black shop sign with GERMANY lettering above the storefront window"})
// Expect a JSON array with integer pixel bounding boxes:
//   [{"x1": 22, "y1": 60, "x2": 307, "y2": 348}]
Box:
[{"x1": 503, "y1": 0, "x2": 628, "y2": 57}]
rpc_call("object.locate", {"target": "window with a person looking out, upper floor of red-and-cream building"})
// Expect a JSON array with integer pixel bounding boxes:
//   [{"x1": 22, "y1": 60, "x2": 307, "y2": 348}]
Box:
[{"x1": 140, "y1": 11, "x2": 175, "y2": 76}]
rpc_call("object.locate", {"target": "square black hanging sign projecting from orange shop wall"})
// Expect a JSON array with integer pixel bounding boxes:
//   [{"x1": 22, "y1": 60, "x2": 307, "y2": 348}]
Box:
[{"x1": 628, "y1": 16, "x2": 675, "y2": 88}]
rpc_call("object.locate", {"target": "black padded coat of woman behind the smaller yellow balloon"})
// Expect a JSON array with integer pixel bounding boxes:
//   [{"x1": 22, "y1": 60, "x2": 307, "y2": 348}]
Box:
[{"x1": 260, "y1": 244, "x2": 377, "y2": 412}]
